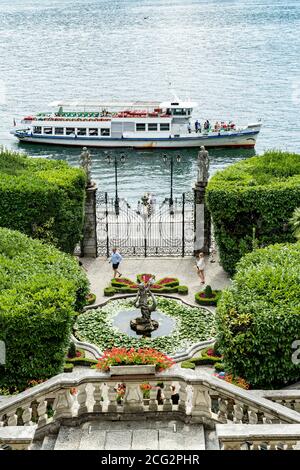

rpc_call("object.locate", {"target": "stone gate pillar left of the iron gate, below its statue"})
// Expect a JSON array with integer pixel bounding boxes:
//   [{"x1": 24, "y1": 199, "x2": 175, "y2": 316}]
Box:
[{"x1": 81, "y1": 183, "x2": 97, "y2": 258}]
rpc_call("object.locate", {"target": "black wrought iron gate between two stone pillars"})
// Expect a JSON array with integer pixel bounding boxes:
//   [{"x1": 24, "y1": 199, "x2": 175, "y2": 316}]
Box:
[{"x1": 97, "y1": 192, "x2": 194, "y2": 257}]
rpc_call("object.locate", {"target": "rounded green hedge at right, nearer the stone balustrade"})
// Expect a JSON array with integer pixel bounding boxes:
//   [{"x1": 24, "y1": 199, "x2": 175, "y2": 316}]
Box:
[{"x1": 216, "y1": 243, "x2": 300, "y2": 388}]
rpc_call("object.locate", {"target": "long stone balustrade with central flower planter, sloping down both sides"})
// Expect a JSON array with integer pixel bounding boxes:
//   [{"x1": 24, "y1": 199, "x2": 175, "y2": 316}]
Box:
[{"x1": 0, "y1": 366, "x2": 300, "y2": 439}]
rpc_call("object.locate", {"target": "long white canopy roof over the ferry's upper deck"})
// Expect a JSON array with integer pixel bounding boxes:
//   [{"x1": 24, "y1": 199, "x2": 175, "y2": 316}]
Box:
[{"x1": 49, "y1": 101, "x2": 197, "y2": 109}]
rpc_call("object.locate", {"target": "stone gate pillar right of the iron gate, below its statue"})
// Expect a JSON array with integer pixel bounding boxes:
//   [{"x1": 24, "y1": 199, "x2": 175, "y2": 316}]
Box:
[{"x1": 194, "y1": 182, "x2": 211, "y2": 256}]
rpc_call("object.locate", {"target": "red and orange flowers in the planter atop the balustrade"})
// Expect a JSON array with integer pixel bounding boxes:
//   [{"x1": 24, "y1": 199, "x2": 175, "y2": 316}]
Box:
[{"x1": 96, "y1": 348, "x2": 174, "y2": 372}]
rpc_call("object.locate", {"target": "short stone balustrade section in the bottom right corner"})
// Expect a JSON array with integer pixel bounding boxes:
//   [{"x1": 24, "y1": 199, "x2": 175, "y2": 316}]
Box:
[{"x1": 216, "y1": 424, "x2": 300, "y2": 450}]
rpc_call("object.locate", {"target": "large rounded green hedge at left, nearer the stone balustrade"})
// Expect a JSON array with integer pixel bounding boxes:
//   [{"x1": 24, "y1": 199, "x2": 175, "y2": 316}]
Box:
[{"x1": 0, "y1": 228, "x2": 89, "y2": 390}]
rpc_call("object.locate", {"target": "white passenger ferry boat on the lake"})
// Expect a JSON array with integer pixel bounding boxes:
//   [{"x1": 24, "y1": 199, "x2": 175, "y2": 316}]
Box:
[{"x1": 11, "y1": 99, "x2": 261, "y2": 149}]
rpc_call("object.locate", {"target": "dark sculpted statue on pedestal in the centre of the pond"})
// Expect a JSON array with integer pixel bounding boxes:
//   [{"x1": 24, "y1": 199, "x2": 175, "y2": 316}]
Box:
[{"x1": 130, "y1": 279, "x2": 159, "y2": 336}]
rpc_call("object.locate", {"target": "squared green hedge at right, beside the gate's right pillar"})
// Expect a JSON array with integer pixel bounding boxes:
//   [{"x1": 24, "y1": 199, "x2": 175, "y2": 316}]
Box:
[{"x1": 206, "y1": 151, "x2": 300, "y2": 274}]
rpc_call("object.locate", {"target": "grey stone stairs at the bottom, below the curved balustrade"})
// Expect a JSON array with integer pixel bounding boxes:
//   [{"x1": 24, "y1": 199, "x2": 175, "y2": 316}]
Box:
[{"x1": 30, "y1": 421, "x2": 210, "y2": 450}]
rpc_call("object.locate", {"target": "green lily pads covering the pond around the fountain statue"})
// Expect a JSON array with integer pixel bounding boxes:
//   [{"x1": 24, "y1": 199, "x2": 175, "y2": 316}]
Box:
[{"x1": 74, "y1": 297, "x2": 215, "y2": 354}]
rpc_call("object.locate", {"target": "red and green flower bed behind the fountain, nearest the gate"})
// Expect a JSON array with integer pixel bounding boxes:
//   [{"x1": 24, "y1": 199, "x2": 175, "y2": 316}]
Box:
[{"x1": 104, "y1": 273, "x2": 187, "y2": 296}]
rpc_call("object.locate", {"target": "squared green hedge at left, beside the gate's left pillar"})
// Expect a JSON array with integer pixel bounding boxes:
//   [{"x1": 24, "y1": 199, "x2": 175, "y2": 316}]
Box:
[{"x1": 0, "y1": 150, "x2": 85, "y2": 253}]
